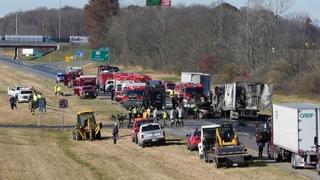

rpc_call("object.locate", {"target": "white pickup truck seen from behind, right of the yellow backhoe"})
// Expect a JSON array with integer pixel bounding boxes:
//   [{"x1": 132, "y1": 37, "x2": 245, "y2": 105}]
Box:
[{"x1": 138, "y1": 123, "x2": 166, "y2": 147}]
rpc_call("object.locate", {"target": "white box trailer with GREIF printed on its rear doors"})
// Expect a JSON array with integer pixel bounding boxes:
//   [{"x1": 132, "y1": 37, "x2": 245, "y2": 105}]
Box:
[{"x1": 272, "y1": 103, "x2": 320, "y2": 168}]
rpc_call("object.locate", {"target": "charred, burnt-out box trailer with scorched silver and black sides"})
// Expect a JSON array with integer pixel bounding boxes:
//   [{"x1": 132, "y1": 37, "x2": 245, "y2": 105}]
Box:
[{"x1": 213, "y1": 82, "x2": 273, "y2": 119}]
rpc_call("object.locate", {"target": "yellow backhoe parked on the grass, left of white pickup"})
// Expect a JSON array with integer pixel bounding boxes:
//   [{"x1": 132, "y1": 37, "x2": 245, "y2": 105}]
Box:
[{"x1": 72, "y1": 110, "x2": 102, "y2": 141}]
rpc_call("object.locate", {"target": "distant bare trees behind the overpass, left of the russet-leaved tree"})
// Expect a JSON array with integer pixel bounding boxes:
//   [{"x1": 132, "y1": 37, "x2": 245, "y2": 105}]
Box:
[{"x1": 0, "y1": 6, "x2": 87, "y2": 39}]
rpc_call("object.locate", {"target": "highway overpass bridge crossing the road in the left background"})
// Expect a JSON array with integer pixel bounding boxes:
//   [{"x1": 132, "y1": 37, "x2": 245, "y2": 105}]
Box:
[{"x1": 0, "y1": 41, "x2": 60, "y2": 59}]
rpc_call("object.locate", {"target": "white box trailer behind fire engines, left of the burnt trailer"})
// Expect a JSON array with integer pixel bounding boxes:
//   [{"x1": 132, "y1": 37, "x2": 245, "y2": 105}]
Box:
[{"x1": 181, "y1": 72, "x2": 211, "y2": 95}]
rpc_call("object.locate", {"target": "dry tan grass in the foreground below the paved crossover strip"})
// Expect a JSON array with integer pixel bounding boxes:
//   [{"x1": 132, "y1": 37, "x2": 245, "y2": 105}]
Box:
[{"x1": 0, "y1": 128, "x2": 306, "y2": 180}]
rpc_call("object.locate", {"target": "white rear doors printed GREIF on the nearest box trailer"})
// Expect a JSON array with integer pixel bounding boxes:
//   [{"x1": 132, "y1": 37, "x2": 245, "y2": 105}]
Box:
[{"x1": 298, "y1": 109, "x2": 317, "y2": 151}]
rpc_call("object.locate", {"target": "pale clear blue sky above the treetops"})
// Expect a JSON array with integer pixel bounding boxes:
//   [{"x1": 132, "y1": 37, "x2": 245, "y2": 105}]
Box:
[{"x1": 0, "y1": 0, "x2": 320, "y2": 21}]
